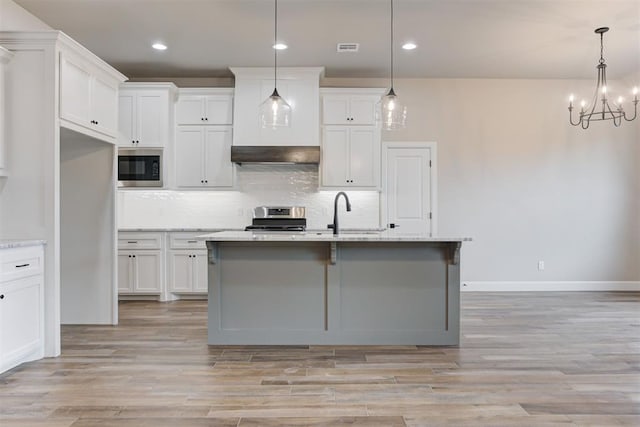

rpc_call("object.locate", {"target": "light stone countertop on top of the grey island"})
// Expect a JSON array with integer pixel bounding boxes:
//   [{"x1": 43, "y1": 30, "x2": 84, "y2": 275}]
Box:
[{"x1": 198, "y1": 230, "x2": 471, "y2": 242}]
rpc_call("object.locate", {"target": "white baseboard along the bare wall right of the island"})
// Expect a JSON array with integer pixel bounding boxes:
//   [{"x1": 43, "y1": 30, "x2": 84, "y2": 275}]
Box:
[{"x1": 460, "y1": 281, "x2": 640, "y2": 292}]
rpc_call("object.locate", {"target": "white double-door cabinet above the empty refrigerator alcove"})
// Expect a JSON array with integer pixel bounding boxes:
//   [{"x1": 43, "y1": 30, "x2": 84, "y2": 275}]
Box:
[{"x1": 60, "y1": 50, "x2": 120, "y2": 142}]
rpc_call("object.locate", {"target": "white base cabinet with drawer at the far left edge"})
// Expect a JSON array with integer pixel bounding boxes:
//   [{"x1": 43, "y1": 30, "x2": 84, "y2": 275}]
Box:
[{"x1": 0, "y1": 245, "x2": 44, "y2": 372}]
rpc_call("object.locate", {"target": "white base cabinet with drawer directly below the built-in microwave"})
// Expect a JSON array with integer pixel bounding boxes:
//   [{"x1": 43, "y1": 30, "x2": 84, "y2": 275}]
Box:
[{"x1": 118, "y1": 232, "x2": 163, "y2": 296}]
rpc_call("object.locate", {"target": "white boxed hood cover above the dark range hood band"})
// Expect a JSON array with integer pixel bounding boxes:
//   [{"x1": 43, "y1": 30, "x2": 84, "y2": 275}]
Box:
[{"x1": 231, "y1": 67, "x2": 324, "y2": 146}]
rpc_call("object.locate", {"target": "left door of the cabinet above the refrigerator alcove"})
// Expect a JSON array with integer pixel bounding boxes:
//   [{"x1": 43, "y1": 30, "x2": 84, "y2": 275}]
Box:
[{"x1": 60, "y1": 56, "x2": 93, "y2": 127}]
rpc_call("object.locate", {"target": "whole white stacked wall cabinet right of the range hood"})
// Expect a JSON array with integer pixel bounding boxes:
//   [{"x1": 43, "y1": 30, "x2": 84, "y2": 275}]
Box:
[{"x1": 320, "y1": 88, "x2": 384, "y2": 190}]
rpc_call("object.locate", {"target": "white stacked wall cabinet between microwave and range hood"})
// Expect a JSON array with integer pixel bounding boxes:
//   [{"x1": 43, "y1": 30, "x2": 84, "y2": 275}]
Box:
[{"x1": 174, "y1": 89, "x2": 235, "y2": 189}]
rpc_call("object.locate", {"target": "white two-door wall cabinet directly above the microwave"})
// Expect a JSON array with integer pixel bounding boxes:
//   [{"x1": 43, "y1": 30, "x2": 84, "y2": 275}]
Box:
[{"x1": 118, "y1": 83, "x2": 177, "y2": 147}]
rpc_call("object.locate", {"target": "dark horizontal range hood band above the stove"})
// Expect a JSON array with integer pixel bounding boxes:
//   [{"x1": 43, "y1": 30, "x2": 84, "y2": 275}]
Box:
[{"x1": 231, "y1": 145, "x2": 320, "y2": 165}]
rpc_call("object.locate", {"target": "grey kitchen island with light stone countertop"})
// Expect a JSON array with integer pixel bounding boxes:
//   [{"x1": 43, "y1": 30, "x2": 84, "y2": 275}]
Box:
[{"x1": 200, "y1": 231, "x2": 470, "y2": 345}]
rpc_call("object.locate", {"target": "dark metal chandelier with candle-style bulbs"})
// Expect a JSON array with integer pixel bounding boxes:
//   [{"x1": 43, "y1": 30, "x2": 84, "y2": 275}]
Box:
[{"x1": 569, "y1": 27, "x2": 638, "y2": 129}]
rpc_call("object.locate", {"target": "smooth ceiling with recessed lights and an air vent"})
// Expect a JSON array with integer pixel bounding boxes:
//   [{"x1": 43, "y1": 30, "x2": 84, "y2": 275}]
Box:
[{"x1": 15, "y1": 0, "x2": 640, "y2": 78}]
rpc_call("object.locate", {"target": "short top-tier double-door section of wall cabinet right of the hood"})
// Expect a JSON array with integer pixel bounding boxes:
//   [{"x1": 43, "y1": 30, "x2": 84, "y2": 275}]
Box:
[{"x1": 321, "y1": 88, "x2": 384, "y2": 125}]
